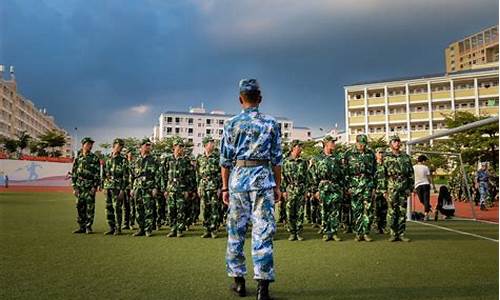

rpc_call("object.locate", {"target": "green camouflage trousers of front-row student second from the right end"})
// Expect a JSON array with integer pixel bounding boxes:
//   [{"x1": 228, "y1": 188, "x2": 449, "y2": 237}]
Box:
[{"x1": 351, "y1": 186, "x2": 373, "y2": 235}]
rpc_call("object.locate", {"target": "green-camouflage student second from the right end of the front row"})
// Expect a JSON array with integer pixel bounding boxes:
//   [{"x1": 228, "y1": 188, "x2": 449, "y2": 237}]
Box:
[{"x1": 344, "y1": 134, "x2": 376, "y2": 242}]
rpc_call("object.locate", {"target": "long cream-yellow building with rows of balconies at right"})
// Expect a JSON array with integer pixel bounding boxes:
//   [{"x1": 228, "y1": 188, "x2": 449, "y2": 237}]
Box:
[{"x1": 344, "y1": 68, "x2": 499, "y2": 143}]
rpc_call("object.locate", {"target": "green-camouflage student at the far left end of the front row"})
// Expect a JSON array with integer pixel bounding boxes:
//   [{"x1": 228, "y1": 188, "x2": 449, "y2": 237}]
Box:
[{"x1": 71, "y1": 137, "x2": 101, "y2": 234}]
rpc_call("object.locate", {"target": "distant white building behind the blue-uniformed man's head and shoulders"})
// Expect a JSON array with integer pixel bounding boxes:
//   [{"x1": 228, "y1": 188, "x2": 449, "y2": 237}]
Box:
[{"x1": 153, "y1": 106, "x2": 311, "y2": 155}]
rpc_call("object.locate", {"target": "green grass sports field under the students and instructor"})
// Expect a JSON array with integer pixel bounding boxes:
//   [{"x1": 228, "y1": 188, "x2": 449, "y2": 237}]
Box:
[{"x1": 0, "y1": 192, "x2": 499, "y2": 299}]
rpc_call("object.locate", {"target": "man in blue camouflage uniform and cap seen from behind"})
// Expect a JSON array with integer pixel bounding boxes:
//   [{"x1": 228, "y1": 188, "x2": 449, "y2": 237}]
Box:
[{"x1": 220, "y1": 79, "x2": 283, "y2": 299}]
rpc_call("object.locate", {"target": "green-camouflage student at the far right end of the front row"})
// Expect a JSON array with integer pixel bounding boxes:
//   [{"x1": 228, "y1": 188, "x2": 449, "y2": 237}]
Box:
[{"x1": 384, "y1": 135, "x2": 415, "y2": 242}]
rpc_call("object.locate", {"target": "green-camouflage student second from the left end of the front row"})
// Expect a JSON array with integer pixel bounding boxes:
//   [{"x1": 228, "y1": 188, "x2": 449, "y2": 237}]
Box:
[{"x1": 102, "y1": 139, "x2": 130, "y2": 235}]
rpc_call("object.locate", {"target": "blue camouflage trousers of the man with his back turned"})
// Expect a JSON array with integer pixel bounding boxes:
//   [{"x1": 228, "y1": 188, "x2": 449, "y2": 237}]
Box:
[{"x1": 226, "y1": 189, "x2": 276, "y2": 281}]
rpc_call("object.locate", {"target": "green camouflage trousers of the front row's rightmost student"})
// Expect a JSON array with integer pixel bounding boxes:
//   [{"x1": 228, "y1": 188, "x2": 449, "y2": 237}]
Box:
[{"x1": 387, "y1": 189, "x2": 408, "y2": 237}]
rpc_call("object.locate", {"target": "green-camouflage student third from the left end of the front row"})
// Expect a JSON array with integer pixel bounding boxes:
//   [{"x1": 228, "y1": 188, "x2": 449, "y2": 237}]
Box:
[{"x1": 132, "y1": 138, "x2": 161, "y2": 237}]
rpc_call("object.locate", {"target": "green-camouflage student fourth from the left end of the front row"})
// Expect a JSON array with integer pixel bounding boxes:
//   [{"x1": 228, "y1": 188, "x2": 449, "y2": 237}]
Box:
[{"x1": 162, "y1": 137, "x2": 194, "y2": 237}]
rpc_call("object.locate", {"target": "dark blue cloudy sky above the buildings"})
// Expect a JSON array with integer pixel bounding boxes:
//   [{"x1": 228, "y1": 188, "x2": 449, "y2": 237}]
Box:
[{"x1": 0, "y1": 0, "x2": 498, "y2": 145}]
